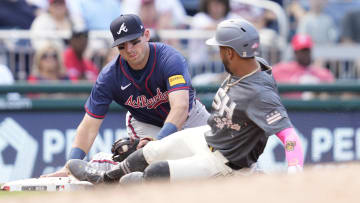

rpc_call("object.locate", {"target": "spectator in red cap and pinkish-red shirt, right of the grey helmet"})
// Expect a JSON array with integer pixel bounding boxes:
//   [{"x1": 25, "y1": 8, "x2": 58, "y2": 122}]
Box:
[{"x1": 273, "y1": 34, "x2": 334, "y2": 99}]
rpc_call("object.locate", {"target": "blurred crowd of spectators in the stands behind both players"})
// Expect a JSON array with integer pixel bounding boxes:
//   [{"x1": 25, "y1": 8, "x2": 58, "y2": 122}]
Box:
[{"x1": 0, "y1": 0, "x2": 360, "y2": 100}]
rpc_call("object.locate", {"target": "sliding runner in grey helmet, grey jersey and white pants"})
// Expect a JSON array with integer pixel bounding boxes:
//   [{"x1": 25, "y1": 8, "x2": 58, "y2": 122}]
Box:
[{"x1": 68, "y1": 19, "x2": 303, "y2": 184}]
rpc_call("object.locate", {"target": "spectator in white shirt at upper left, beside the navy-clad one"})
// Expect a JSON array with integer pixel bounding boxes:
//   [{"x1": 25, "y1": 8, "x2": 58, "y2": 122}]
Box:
[{"x1": 30, "y1": 0, "x2": 72, "y2": 49}]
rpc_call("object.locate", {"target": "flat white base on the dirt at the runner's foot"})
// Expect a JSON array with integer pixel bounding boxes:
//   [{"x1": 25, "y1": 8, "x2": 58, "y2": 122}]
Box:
[{"x1": 1, "y1": 177, "x2": 94, "y2": 192}]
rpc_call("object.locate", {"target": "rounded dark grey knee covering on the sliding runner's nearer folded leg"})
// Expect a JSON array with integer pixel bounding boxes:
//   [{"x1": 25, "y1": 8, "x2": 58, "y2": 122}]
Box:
[{"x1": 144, "y1": 161, "x2": 170, "y2": 181}]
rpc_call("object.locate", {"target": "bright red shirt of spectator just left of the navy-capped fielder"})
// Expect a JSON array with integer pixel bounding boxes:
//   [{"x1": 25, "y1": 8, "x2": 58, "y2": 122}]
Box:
[{"x1": 64, "y1": 47, "x2": 99, "y2": 81}]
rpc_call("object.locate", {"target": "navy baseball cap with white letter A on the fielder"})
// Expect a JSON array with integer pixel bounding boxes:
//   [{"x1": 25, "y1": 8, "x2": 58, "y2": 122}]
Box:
[{"x1": 110, "y1": 14, "x2": 145, "y2": 47}]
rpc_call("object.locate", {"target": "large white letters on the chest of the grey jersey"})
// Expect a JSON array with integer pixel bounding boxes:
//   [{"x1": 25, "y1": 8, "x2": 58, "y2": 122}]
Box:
[{"x1": 212, "y1": 88, "x2": 236, "y2": 119}]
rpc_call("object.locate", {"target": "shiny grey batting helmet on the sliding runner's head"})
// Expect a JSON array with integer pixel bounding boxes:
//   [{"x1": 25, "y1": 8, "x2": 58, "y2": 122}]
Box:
[{"x1": 206, "y1": 18, "x2": 260, "y2": 58}]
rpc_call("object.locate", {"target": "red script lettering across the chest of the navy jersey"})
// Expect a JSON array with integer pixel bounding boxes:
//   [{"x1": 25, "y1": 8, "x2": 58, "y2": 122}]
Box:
[{"x1": 125, "y1": 88, "x2": 168, "y2": 109}]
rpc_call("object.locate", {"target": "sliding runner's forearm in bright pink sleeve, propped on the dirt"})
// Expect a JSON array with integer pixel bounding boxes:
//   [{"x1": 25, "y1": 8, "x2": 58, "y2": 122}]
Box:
[{"x1": 276, "y1": 128, "x2": 304, "y2": 167}]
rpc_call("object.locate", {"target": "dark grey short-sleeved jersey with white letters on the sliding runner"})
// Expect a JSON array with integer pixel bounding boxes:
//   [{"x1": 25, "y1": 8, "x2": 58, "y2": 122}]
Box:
[{"x1": 205, "y1": 65, "x2": 292, "y2": 169}]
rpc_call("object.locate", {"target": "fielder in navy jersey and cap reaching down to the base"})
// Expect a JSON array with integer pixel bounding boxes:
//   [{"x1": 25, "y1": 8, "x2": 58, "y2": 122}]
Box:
[{"x1": 42, "y1": 14, "x2": 209, "y2": 177}]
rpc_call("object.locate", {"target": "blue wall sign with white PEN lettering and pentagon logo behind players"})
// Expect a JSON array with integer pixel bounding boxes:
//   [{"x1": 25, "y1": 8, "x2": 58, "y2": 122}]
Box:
[{"x1": 0, "y1": 111, "x2": 360, "y2": 182}]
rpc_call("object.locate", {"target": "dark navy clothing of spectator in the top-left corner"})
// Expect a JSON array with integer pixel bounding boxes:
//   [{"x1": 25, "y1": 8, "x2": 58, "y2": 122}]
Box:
[{"x1": 0, "y1": 0, "x2": 37, "y2": 29}]
